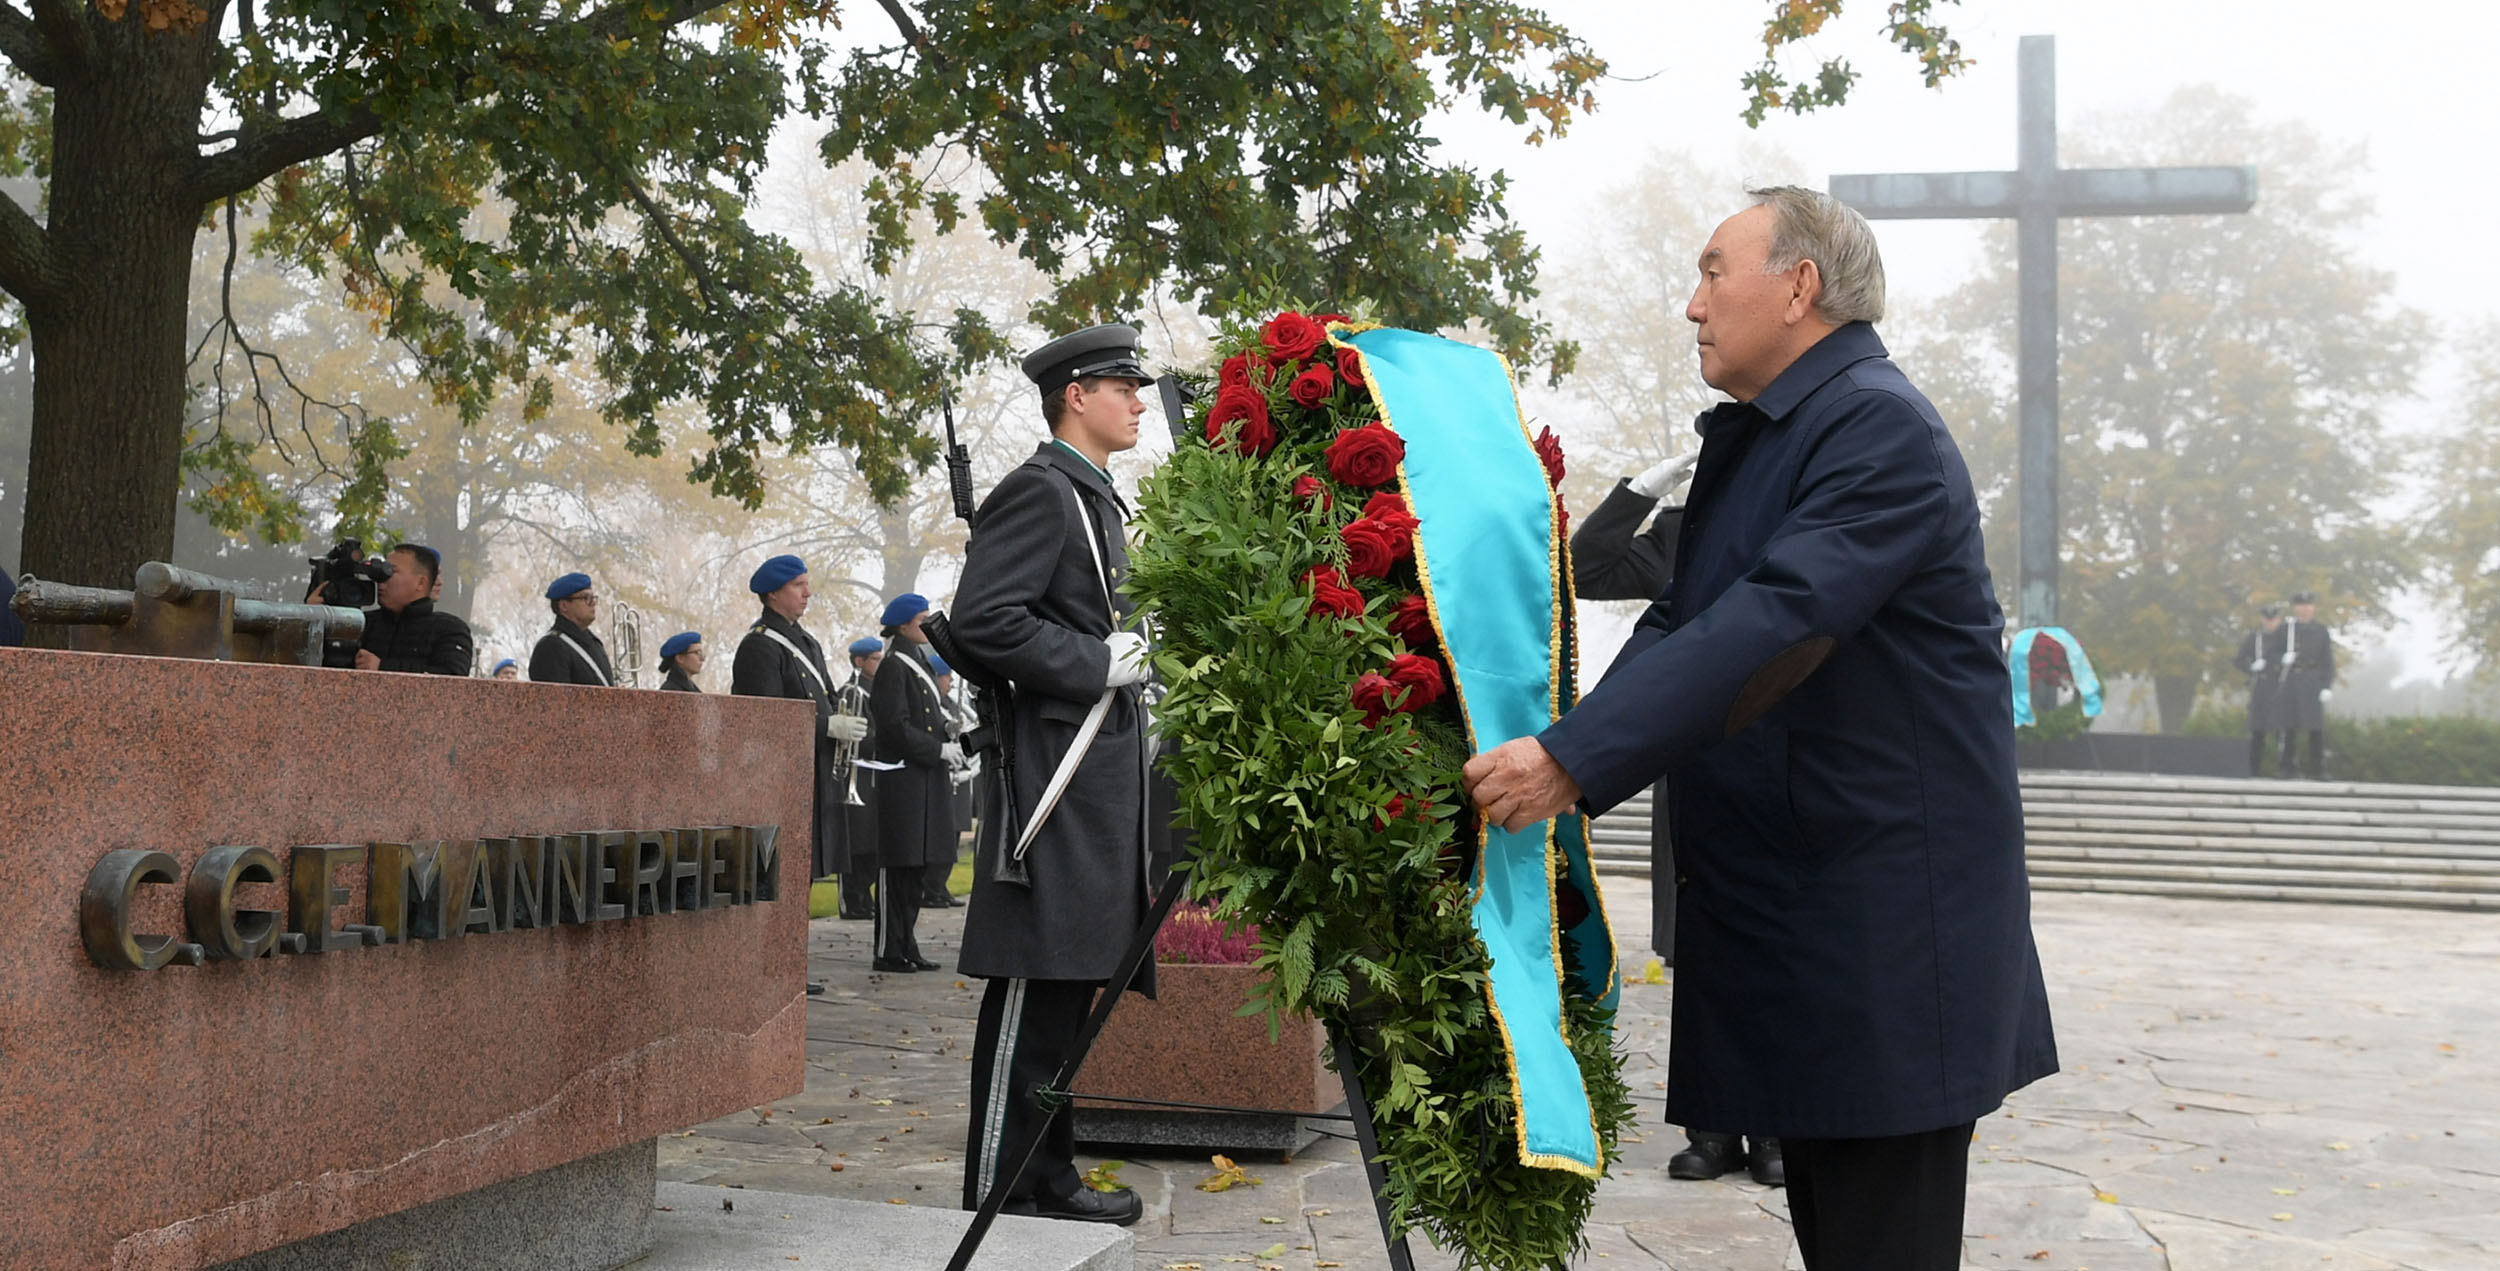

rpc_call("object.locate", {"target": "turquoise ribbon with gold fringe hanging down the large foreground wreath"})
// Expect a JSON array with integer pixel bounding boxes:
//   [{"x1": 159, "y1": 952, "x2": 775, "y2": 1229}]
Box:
[{"x1": 1338, "y1": 330, "x2": 1615, "y2": 1173}]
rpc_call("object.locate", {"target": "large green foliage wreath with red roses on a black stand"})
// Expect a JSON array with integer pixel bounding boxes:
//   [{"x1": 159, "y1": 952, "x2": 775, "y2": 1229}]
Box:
[{"x1": 1128, "y1": 313, "x2": 1633, "y2": 1268}]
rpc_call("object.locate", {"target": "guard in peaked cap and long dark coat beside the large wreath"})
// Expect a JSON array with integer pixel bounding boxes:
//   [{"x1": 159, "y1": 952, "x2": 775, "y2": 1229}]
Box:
[{"x1": 953, "y1": 325, "x2": 1153, "y2": 1226}]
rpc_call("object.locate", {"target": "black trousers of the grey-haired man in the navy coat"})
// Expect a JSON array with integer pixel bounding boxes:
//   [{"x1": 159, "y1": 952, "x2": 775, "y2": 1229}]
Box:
[{"x1": 1780, "y1": 1121, "x2": 1973, "y2": 1271}]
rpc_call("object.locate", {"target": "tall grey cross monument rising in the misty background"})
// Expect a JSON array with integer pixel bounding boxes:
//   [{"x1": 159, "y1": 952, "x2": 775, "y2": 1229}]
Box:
[{"x1": 1833, "y1": 35, "x2": 2258, "y2": 625}]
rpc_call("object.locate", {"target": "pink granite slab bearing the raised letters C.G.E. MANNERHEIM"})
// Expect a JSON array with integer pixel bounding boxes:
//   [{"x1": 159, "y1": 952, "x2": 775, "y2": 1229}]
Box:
[{"x1": 0, "y1": 648, "x2": 815, "y2": 1271}]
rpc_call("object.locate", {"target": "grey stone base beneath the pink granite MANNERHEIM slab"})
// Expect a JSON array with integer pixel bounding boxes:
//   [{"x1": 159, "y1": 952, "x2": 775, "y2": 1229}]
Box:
[{"x1": 215, "y1": 1141, "x2": 660, "y2": 1271}]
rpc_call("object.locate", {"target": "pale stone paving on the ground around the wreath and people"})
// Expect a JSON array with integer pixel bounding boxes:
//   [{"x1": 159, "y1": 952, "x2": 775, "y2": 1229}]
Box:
[{"x1": 660, "y1": 878, "x2": 2500, "y2": 1271}]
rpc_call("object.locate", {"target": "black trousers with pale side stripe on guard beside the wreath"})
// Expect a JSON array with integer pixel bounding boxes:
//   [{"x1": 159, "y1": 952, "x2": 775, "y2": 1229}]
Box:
[{"x1": 963, "y1": 981, "x2": 1098, "y2": 1208}]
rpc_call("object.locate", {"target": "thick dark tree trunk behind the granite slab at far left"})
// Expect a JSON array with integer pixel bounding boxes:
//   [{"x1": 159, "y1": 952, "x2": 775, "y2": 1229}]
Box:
[{"x1": 25, "y1": 5, "x2": 223, "y2": 588}]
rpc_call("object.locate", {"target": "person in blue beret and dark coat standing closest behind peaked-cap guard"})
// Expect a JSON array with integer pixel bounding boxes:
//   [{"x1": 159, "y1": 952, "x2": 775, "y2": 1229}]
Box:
[{"x1": 868, "y1": 593, "x2": 963, "y2": 973}]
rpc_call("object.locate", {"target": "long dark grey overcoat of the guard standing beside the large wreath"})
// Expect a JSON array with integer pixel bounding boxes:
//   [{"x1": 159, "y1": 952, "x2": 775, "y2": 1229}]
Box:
[{"x1": 955, "y1": 443, "x2": 1153, "y2": 991}]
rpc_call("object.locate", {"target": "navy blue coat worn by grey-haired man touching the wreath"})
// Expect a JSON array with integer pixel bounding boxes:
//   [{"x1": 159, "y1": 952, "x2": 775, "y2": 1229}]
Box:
[{"x1": 1538, "y1": 323, "x2": 2058, "y2": 1138}]
